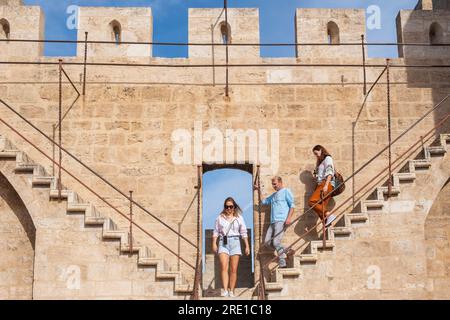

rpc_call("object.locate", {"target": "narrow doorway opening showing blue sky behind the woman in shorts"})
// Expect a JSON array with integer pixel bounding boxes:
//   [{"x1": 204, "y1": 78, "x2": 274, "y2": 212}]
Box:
[{"x1": 202, "y1": 164, "x2": 254, "y2": 295}]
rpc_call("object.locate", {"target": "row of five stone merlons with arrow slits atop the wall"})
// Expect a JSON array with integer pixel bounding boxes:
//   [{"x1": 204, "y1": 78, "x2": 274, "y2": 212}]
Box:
[{"x1": 0, "y1": 0, "x2": 450, "y2": 62}]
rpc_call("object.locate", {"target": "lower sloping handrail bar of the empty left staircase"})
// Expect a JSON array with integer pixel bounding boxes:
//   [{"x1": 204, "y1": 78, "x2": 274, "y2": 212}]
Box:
[{"x1": 0, "y1": 118, "x2": 195, "y2": 269}]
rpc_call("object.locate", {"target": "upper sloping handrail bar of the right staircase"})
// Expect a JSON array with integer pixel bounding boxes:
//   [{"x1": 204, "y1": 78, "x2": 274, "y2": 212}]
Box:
[{"x1": 256, "y1": 94, "x2": 450, "y2": 266}]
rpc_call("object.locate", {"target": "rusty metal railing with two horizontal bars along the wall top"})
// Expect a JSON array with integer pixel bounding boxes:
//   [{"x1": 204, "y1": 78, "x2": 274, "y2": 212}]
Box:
[{"x1": 0, "y1": 35, "x2": 450, "y2": 97}]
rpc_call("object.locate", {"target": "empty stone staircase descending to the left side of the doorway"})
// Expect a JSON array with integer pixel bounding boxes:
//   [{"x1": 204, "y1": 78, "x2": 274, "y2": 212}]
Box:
[{"x1": 0, "y1": 136, "x2": 193, "y2": 294}]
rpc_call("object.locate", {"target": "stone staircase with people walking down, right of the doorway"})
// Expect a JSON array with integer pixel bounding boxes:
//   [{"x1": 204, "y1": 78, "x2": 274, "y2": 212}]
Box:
[{"x1": 266, "y1": 134, "x2": 450, "y2": 296}]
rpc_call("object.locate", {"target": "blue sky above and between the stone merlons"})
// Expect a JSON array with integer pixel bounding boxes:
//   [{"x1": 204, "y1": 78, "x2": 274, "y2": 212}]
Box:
[{"x1": 24, "y1": 0, "x2": 418, "y2": 57}]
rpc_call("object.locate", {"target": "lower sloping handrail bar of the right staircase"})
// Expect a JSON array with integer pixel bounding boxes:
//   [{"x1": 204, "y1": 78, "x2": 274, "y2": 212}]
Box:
[{"x1": 265, "y1": 109, "x2": 450, "y2": 267}]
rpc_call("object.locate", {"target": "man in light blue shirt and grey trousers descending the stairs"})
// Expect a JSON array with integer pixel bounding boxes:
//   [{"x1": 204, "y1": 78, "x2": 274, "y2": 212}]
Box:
[{"x1": 256, "y1": 177, "x2": 295, "y2": 268}]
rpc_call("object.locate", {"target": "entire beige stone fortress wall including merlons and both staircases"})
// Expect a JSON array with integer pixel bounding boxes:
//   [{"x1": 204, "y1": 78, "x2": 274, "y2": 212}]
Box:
[{"x1": 0, "y1": 0, "x2": 450, "y2": 299}]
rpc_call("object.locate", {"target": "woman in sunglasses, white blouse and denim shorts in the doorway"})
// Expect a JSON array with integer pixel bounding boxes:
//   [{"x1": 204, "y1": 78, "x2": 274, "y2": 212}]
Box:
[{"x1": 212, "y1": 197, "x2": 250, "y2": 297}]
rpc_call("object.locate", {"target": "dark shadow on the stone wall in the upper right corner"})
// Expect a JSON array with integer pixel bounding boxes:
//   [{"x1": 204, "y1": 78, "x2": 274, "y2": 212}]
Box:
[{"x1": 397, "y1": 0, "x2": 450, "y2": 137}]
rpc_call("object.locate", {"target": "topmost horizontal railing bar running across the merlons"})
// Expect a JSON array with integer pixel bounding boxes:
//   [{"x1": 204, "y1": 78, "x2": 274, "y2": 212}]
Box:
[{"x1": 0, "y1": 39, "x2": 450, "y2": 47}]
